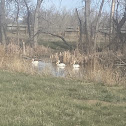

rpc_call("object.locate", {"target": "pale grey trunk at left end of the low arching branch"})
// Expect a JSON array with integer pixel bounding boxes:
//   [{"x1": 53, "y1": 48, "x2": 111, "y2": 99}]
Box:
[{"x1": 33, "y1": 0, "x2": 43, "y2": 48}]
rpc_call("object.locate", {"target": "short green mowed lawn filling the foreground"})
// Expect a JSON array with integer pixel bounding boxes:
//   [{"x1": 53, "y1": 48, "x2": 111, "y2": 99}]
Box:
[{"x1": 0, "y1": 71, "x2": 126, "y2": 126}]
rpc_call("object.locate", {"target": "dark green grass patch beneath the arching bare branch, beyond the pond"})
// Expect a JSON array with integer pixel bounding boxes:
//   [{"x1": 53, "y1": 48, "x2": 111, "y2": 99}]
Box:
[{"x1": 38, "y1": 40, "x2": 76, "y2": 51}]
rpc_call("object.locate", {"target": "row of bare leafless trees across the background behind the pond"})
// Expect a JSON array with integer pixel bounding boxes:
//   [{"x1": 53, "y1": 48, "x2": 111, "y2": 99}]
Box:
[{"x1": 0, "y1": 0, "x2": 126, "y2": 54}]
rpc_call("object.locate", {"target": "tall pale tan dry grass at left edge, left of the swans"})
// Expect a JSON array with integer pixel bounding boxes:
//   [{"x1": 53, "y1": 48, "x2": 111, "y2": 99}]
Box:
[{"x1": 0, "y1": 45, "x2": 34, "y2": 73}]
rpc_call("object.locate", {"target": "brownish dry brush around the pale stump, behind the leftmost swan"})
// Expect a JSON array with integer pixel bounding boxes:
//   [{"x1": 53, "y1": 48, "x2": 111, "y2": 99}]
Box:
[{"x1": 4, "y1": 37, "x2": 52, "y2": 57}]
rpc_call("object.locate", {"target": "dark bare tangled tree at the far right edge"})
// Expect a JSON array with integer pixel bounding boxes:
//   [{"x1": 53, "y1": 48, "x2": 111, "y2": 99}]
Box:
[{"x1": 108, "y1": 0, "x2": 126, "y2": 53}]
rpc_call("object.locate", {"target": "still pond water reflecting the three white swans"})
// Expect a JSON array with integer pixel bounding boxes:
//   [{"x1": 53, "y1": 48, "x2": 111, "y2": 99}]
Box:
[{"x1": 35, "y1": 61, "x2": 86, "y2": 77}]
